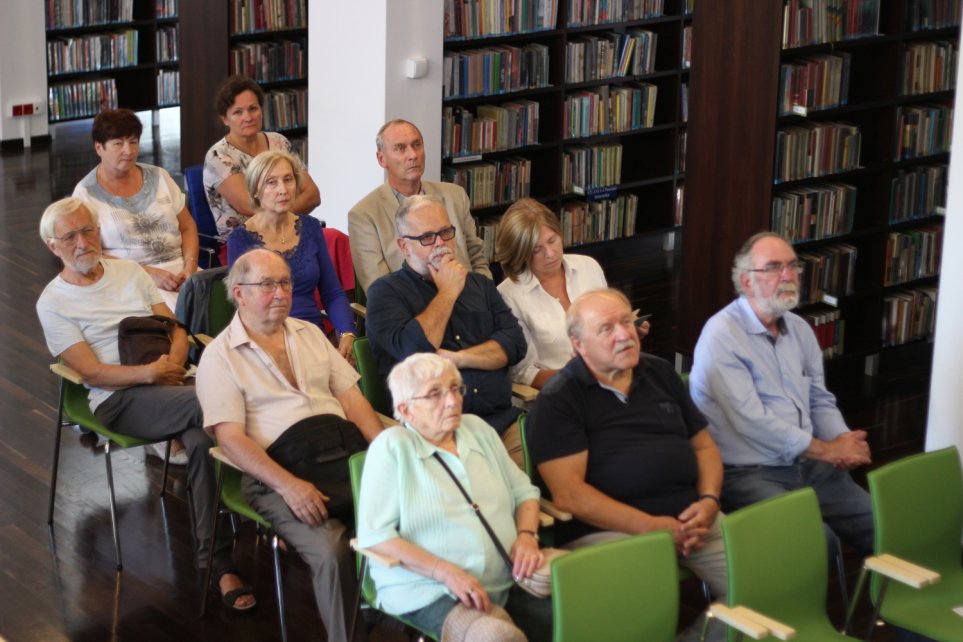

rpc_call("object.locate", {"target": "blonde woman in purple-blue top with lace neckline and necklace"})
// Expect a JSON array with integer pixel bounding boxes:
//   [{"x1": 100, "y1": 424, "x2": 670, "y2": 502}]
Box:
[{"x1": 227, "y1": 151, "x2": 356, "y2": 363}]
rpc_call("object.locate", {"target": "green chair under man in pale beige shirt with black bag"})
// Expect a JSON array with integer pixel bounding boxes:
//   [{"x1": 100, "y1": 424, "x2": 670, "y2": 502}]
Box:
[{"x1": 200, "y1": 446, "x2": 288, "y2": 642}]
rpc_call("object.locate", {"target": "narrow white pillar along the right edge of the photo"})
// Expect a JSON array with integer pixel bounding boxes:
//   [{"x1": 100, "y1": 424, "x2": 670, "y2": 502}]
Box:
[{"x1": 926, "y1": 38, "x2": 963, "y2": 452}]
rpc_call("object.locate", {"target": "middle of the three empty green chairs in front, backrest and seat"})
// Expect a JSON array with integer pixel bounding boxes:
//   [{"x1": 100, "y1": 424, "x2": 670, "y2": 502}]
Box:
[{"x1": 722, "y1": 488, "x2": 853, "y2": 642}]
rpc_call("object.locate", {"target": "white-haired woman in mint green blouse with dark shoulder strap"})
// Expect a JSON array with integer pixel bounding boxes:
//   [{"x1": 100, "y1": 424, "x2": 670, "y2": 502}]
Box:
[{"x1": 358, "y1": 353, "x2": 552, "y2": 641}]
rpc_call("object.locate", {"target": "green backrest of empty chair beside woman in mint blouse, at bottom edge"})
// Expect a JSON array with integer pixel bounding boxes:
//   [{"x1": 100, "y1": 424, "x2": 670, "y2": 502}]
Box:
[{"x1": 552, "y1": 531, "x2": 679, "y2": 642}]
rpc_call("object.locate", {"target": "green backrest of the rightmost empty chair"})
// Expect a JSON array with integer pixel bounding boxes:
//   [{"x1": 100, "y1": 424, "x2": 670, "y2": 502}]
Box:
[{"x1": 866, "y1": 448, "x2": 963, "y2": 572}]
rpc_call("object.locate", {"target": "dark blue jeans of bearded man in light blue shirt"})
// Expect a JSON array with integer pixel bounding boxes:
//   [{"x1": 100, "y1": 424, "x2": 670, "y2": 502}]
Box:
[{"x1": 722, "y1": 459, "x2": 873, "y2": 557}]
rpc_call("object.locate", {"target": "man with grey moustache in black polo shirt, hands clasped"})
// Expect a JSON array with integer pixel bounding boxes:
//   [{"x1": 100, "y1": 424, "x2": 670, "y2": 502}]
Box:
[{"x1": 527, "y1": 289, "x2": 727, "y2": 639}]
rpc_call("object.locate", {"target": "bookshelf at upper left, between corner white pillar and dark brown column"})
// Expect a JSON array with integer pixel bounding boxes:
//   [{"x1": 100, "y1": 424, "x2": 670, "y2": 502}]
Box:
[{"x1": 45, "y1": 0, "x2": 179, "y2": 123}]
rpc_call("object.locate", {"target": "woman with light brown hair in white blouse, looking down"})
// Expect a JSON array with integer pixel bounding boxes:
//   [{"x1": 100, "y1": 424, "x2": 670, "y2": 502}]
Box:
[{"x1": 495, "y1": 198, "x2": 649, "y2": 389}]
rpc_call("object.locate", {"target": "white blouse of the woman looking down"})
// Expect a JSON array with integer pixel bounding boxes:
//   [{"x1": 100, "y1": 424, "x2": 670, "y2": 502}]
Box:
[{"x1": 498, "y1": 254, "x2": 607, "y2": 385}]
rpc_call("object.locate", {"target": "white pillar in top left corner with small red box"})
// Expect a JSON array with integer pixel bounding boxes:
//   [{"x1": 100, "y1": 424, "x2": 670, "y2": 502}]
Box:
[{"x1": 0, "y1": 0, "x2": 48, "y2": 140}]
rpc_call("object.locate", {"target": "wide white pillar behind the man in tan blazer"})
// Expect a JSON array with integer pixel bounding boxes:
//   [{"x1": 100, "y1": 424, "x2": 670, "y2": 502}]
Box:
[{"x1": 308, "y1": 0, "x2": 443, "y2": 232}]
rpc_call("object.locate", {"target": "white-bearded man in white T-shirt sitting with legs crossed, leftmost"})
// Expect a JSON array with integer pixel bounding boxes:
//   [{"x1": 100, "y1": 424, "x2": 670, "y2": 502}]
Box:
[{"x1": 37, "y1": 198, "x2": 255, "y2": 611}]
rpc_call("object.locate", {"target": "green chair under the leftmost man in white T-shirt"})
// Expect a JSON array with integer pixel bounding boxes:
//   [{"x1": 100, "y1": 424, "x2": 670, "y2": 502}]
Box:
[{"x1": 47, "y1": 363, "x2": 173, "y2": 571}]
